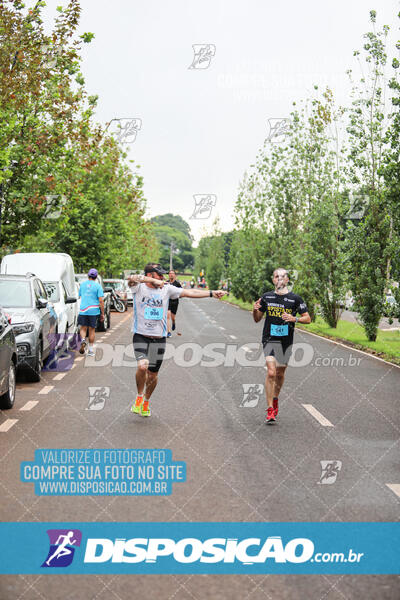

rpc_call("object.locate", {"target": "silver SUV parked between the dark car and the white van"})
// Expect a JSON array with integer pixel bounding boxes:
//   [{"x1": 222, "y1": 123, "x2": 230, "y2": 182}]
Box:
[{"x1": 0, "y1": 273, "x2": 57, "y2": 381}]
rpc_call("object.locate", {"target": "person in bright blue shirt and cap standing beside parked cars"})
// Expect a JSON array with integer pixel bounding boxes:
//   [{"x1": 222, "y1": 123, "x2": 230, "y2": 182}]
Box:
[{"x1": 78, "y1": 269, "x2": 104, "y2": 356}]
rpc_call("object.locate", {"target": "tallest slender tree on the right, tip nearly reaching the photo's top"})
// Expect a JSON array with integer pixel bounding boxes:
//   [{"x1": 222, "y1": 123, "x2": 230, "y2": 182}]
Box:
[{"x1": 347, "y1": 11, "x2": 393, "y2": 341}]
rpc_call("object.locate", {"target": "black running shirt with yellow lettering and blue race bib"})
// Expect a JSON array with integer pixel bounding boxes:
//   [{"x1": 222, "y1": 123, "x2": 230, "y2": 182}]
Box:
[{"x1": 260, "y1": 291, "x2": 308, "y2": 345}]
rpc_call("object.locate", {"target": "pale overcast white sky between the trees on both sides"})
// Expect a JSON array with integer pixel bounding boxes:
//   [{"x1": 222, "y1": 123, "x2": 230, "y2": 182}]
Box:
[{"x1": 38, "y1": 0, "x2": 400, "y2": 241}]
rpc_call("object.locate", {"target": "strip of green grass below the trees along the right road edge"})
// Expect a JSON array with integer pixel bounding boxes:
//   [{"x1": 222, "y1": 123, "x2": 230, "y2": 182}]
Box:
[{"x1": 223, "y1": 294, "x2": 400, "y2": 365}]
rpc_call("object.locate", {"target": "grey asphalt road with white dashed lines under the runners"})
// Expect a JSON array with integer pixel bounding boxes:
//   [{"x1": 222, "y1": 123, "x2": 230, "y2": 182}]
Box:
[{"x1": 0, "y1": 299, "x2": 400, "y2": 600}]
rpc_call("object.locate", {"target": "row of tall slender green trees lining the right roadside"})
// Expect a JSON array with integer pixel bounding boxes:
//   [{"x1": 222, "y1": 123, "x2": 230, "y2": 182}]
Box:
[{"x1": 196, "y1": 11, "x2": 400, "y2": 340}]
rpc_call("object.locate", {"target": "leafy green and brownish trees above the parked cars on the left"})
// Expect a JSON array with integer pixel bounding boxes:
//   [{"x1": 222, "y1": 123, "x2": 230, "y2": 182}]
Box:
[{"x1": 0, "y1": 0, "x2": 157, "y2": 275}]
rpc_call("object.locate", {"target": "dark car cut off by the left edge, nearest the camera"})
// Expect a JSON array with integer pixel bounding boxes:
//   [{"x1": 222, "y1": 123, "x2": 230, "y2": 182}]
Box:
[{"x1": 0, "y1": 306, "x2": 17, "y2": 409}]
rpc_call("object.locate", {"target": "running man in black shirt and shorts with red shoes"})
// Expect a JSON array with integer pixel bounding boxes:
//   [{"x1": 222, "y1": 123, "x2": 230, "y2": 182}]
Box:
[{"x1": 253, "y1": 269, "x2": 311, "y2": 424}]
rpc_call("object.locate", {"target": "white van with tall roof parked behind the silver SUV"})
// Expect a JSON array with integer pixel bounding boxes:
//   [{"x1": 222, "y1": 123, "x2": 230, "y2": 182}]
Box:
[{"x1": 0, "y1": 252, "x2": 78, "y2": 333}]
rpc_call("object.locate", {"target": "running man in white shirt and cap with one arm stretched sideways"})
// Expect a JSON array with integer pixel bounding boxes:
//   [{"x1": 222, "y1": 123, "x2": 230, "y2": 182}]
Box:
[{"x1": 128, "y1": 263, "x2": 226, "y2": 417}]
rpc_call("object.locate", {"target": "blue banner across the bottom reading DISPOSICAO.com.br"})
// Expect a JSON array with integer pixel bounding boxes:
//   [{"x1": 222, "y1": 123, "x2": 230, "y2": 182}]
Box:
[{"x1": 0, "y1": 522, "x2": 400, "y2": 574}]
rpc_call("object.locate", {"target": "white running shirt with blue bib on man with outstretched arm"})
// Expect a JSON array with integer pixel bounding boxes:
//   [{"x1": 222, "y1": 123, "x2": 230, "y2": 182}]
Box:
[{"x1": 130, "y1": 283, "x2": 183, "y2": 337}]
